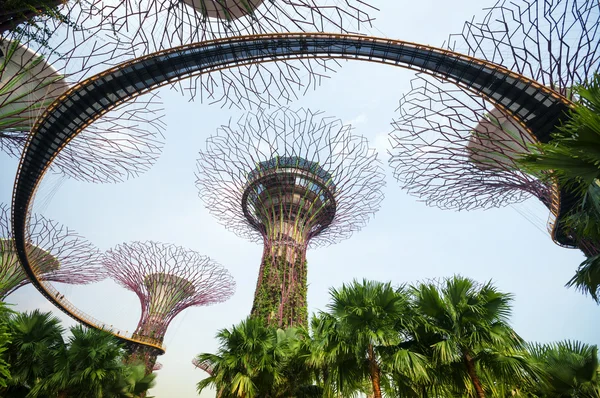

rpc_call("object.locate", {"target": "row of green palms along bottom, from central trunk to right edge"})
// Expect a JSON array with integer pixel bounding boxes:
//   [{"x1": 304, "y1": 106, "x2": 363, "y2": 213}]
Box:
[{"x1": 197, "y1": 276, "x2": 600, "y2": 398}]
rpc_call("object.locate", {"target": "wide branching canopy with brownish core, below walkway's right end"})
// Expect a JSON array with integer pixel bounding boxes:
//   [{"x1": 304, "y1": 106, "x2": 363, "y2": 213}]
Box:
[{"x1": 390, "y1": 75, "x2": 550, "y2": 210}]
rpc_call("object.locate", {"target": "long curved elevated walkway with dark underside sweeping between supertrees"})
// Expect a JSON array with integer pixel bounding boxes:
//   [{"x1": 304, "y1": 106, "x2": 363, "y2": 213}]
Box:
[{"x1": 12, "y1": 33, "x2": 572, "y2": 347}]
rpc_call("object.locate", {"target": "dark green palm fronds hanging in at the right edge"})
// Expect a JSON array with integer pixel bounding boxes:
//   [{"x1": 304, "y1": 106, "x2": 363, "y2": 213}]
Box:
[{"x1": 521, "y1": 74, "x2": 600, "y2": 303}]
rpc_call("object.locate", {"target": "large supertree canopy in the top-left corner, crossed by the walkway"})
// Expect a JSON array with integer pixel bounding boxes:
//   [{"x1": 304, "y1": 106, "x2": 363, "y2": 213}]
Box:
[{"x1": 0, "y1": 1, "x2": 164, "y2": 182}]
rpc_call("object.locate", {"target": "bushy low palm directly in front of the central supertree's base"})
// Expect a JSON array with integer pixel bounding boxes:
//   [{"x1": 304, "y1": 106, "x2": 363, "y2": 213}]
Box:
[{"x1": 197, "y1": 318, "x2": 307, "y2": 398}]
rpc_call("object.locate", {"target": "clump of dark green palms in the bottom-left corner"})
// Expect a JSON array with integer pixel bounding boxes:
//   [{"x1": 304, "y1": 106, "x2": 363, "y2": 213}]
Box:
[{"x1": 0, "y1": 310, "x2": 154, "y2": 398}]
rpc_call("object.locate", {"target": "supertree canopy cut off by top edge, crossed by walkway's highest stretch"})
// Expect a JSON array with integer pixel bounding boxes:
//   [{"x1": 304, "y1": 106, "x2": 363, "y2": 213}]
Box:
[{"x1": 94, "y1": 0, "x2": 376, "y2": 109}]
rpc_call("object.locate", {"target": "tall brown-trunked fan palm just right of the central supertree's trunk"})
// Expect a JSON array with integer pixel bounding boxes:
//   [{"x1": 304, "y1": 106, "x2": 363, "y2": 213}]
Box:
[{"x1": 328, "y1": 280, "x2": 427, "y2": 398}]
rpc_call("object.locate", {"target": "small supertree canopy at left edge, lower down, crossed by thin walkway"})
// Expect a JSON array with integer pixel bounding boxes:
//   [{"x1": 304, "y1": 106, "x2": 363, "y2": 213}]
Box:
[{"x1": 0, "y1": 204, "x2": 106, "y2": 299}]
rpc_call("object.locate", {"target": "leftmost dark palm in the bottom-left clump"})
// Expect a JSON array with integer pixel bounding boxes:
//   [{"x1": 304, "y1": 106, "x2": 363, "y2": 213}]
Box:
[{"x1": 6, "y1": 310, "x2": 64, "y2": 390}]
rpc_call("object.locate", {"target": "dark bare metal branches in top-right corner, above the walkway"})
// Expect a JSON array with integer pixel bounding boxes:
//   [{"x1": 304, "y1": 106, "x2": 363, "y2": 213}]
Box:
[{"x1": 448, "y1": 0, "x2": 600, "y2": 95}]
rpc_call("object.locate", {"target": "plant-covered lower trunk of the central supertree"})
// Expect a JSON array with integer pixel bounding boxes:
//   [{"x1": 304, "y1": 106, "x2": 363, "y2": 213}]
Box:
[{"x1": 252, "y1": 247, "x2": 308, "y2": 328}]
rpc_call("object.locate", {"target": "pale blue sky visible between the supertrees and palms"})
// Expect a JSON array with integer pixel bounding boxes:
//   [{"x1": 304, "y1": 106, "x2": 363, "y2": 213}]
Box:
[{"x1": 0, "y1": 0, "x2": 600, "y2": 398}]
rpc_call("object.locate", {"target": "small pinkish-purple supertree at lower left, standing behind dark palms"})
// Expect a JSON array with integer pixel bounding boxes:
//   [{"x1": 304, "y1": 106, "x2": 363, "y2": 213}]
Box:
[{"x1": 102, "y1": 242, "x2": 235, "y2": 373}]
